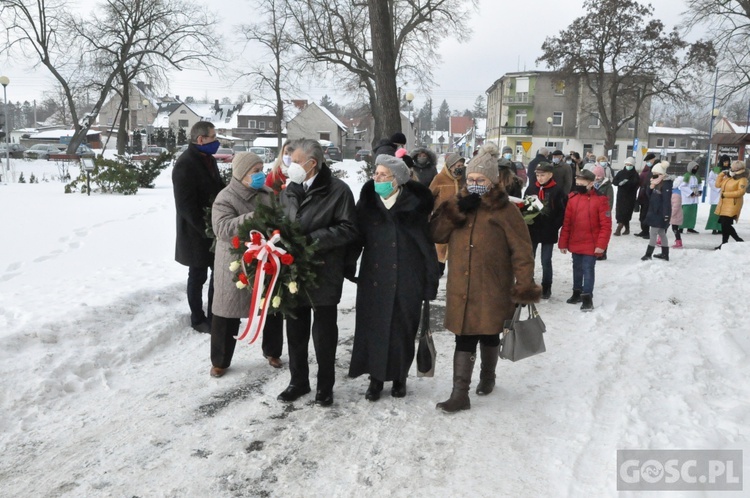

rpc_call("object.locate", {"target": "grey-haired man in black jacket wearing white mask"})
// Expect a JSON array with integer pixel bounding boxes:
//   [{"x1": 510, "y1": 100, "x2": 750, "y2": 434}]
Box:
[{"x1": 278, "y1": 139, "x2": 357, "y2": 406}]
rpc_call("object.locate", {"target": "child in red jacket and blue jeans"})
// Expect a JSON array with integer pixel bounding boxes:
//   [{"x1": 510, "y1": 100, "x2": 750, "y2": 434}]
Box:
[{"x1": 558, "y1": 170, "x2": 612, "y2": 311}]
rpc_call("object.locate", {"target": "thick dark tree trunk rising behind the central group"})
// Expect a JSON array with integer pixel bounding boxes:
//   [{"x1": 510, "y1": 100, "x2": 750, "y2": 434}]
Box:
[{"x1": 367, "y1": 0, "x2": 402, "y2": 146}]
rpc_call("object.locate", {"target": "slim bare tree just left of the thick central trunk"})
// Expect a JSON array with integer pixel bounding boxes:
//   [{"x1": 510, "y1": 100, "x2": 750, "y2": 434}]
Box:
[{"x1": 240, "y1": 0, "x2": 299, "y2": 153}]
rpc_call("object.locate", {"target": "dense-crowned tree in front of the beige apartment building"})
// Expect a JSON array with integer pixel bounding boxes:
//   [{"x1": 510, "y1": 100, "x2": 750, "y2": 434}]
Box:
[{"x1": 537, "y1": 0, "x2": 715, "y2": 154}]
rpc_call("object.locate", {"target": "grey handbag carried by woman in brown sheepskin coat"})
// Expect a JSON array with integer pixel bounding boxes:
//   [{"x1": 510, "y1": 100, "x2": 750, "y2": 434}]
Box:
[{"x1": 499, "y1": 304, "x2": 547, "y2": 361}]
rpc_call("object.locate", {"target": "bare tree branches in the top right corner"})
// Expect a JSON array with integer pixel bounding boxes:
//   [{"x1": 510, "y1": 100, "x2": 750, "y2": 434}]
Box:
[{"x1": 685, "y1": 0, "x2": 750, "y2": 97}]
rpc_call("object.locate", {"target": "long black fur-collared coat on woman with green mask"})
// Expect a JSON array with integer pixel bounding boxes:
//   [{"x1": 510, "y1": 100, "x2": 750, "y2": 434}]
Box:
[{"x1": 349, "y1": 181, "x2": 440, "y2": 381}]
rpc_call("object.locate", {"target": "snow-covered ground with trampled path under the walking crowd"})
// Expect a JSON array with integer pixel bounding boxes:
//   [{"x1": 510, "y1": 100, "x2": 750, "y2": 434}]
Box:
[{"x1": 0, "y1": 160, "x2": 750, "y2": 497}]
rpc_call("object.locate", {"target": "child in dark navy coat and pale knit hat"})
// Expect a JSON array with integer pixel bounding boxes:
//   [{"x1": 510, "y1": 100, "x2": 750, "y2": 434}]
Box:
[{"x1": 641, "y1": 161, "x2": 684, "y2": 261}]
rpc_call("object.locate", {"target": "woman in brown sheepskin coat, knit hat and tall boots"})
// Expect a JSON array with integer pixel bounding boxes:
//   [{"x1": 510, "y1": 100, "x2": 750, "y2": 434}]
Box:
[{"x1": 430, "y1": 151, "x2": 542, "y2": 413}]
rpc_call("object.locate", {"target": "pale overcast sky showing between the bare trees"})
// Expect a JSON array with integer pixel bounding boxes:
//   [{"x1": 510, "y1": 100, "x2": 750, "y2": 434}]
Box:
[{"x1": 0, "y1": 0, "x2": 692, "y2": 112}]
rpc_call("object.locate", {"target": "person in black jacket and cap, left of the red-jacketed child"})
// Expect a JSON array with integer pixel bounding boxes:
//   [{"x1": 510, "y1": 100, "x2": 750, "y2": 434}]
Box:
[{"x1": 526, "y1": 162, "x2": 568, "y2": 299}]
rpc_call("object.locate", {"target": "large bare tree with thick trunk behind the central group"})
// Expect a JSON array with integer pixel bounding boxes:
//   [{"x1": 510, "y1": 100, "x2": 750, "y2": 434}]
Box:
[{"x1": 286, "y1": 0, "x2": 476, "y2": 146}]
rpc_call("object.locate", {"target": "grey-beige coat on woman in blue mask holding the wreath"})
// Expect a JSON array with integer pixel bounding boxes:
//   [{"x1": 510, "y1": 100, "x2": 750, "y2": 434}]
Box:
[{"x1": 211, "y1": 178, "x2": 274, "y2": 318}]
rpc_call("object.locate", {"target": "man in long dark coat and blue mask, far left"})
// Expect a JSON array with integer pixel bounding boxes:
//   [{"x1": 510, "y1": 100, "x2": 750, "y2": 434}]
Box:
[{"x1": 172, "y1": 121, "x2": 224, "y2": 333}]
